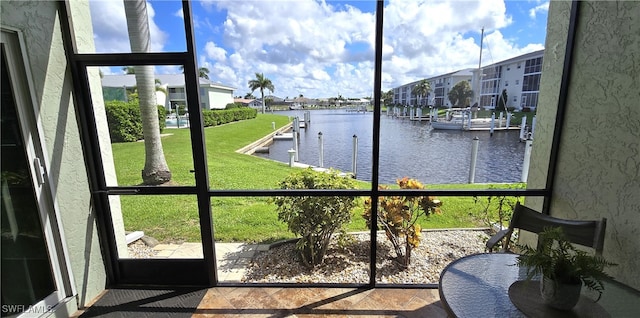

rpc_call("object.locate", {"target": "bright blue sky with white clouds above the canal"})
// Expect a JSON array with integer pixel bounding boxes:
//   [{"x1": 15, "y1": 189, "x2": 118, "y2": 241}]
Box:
[{"x1": 90, "y1": 0, "x2": 549, "y2": 98}]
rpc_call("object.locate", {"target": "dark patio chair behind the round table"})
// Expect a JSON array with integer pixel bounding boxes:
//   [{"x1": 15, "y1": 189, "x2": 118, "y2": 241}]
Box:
[{"x1": 486, "y1": 202, "x2": 607, "y2": 255}]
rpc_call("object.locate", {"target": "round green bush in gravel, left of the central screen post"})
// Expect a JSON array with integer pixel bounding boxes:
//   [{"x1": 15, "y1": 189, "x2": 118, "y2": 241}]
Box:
[{"x1": 274, "y1": 168, "x2": 355, "y2": 267}]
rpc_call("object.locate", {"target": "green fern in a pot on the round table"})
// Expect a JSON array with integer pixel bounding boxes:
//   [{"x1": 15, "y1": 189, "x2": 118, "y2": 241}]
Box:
[{"x1": 517, "y1": 227, "x2": 616, "y2": 310}]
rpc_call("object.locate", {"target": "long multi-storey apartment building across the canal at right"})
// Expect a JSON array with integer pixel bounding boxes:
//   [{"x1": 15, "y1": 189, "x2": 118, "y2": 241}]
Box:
[{"x1": 393, "y1": 50, "x2": 544, "y2": 110}]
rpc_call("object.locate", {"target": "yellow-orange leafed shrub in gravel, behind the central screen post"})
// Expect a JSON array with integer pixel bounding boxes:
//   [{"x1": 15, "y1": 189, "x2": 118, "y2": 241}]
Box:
[{"x1": 362, "y1": 177, "x2": 442, "y2": 268}]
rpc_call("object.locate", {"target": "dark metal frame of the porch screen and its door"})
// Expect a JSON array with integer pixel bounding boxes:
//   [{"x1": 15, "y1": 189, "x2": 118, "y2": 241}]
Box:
[{"x1": 59, "y1": 0, "x2": 577, "y2": 288}]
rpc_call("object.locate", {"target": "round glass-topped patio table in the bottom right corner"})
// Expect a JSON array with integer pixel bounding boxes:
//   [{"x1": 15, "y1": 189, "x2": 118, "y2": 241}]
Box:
[{"x1": 438, "y1": 253, "x2": 640, "y2": 317}]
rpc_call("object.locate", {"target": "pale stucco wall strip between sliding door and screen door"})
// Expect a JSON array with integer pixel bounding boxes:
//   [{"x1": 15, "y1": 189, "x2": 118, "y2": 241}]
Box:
[{"x1": 1, "y1": 1, "x2": 106, "y2": 305}]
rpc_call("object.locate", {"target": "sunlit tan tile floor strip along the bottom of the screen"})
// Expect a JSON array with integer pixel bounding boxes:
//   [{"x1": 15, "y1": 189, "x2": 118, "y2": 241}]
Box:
[{"x1": 193, "y1": 287, "x2": 447, "y2": 318}]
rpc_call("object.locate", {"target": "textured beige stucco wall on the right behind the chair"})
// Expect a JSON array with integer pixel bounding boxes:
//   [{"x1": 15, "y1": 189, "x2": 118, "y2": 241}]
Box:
[{"x1": 527, "y1": 1, "x2": 640, "y2": 289}]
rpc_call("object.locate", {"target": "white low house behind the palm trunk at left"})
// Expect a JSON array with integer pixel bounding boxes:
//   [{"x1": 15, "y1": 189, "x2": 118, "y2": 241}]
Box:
[{"x1": 102, "y1": 74, "x2": 234, "y2": 110}]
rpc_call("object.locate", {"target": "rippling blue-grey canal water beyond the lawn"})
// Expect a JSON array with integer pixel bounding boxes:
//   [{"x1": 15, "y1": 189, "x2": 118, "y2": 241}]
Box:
[{"x1": 256, "y1": 109, "x2": 525, "y2": 184}]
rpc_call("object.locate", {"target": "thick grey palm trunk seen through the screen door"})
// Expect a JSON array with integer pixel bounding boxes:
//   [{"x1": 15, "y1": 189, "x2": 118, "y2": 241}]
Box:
[{"x1": 123, "y1": 0, "x2": 171, "y2": 185}]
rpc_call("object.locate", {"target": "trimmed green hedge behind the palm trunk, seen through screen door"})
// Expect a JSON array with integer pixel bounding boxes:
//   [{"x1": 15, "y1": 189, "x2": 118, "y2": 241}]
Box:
[{"x1": 105, "y1": 101, "x2": 166, "y2": 142}]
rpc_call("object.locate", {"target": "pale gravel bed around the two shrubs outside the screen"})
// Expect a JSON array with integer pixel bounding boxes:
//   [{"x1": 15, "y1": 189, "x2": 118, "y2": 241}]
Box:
[{"x1": 243, "y1": 230, "x2": 489, "y2": 284}]
